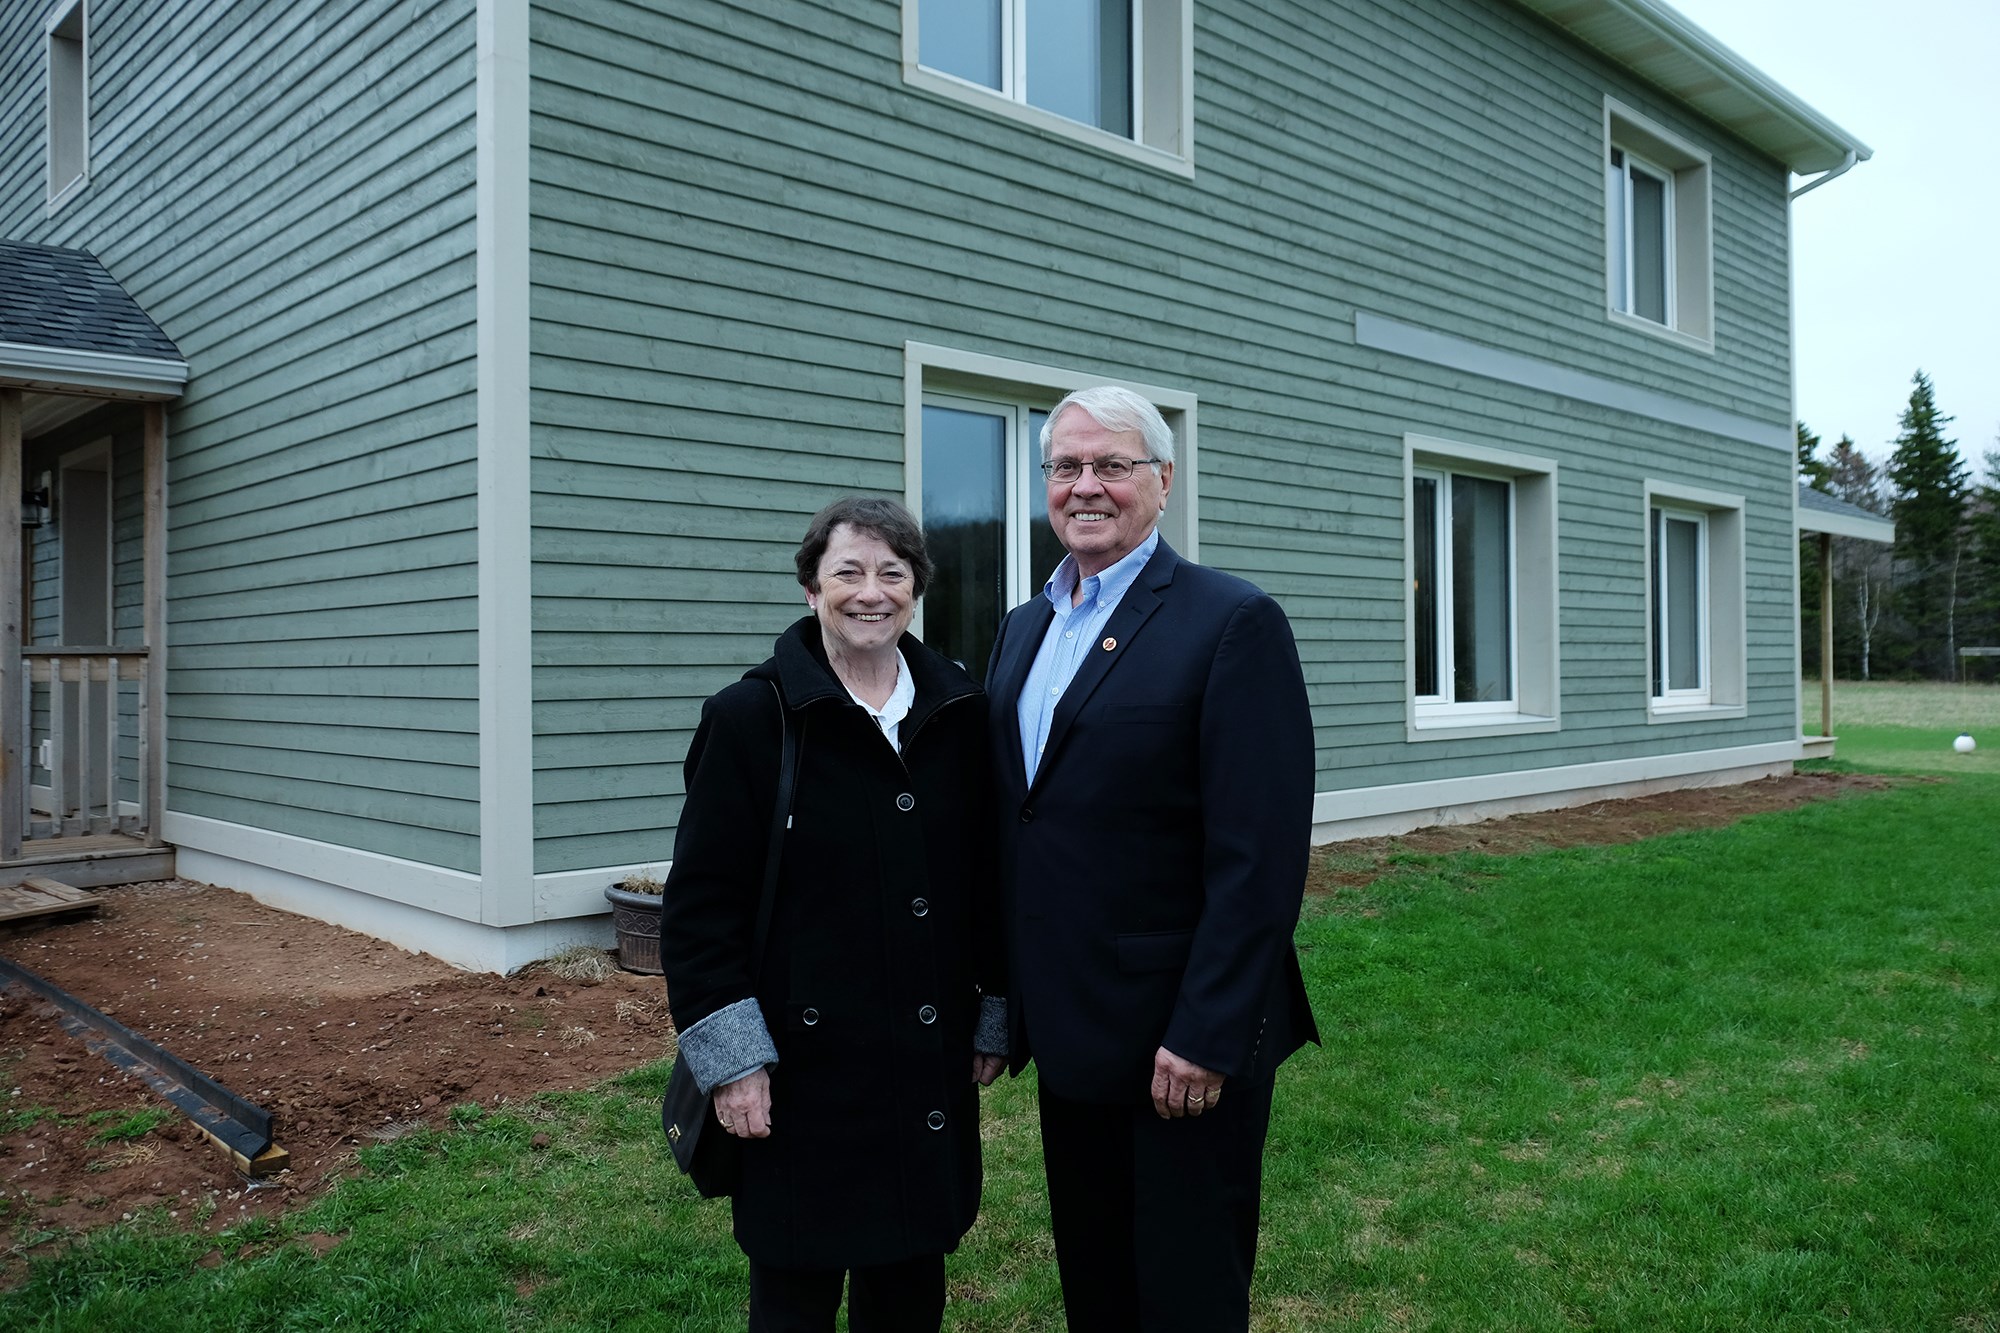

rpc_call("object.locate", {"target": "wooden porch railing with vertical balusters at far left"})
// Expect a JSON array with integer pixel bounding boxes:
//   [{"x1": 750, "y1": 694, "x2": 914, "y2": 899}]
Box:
[{"x1": 20, "y1": 646, "x2": 158, "y2": 839}]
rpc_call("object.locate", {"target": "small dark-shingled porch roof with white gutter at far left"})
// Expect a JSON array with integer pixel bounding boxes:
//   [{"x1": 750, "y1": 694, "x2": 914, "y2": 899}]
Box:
[{"x1": 0, "y1": 240, "x2": 188, "y2": 398}]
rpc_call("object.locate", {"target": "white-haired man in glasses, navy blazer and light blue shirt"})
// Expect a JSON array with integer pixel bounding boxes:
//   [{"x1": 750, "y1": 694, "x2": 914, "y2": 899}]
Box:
[{"x1": 986, "y1": 388, "x2": 1318, "y2": 1333}]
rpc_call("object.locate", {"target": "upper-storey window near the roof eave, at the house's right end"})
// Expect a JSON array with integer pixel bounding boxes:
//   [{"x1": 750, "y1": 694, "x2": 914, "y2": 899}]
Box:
[{"x1": 1604, "y1": 102, "x2": 1714, "y2": 348}]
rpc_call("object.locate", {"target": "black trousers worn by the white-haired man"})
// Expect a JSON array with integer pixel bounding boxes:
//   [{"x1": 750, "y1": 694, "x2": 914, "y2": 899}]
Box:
[{"x1": 1040, "y1": 1075, "x2": 1272, "y2": 1333}]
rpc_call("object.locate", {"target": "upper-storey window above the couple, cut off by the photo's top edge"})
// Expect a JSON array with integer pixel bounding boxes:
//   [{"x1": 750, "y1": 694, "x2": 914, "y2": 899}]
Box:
[{"x1": 904, "y1": 0, "x2": 1194, "y2": 166}]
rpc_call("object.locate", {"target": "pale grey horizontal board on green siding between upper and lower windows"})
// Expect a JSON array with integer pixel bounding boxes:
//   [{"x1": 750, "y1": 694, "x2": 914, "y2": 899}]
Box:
[{"x1": 1354, "y1": 310, "x2": 1798, "y2": 450}]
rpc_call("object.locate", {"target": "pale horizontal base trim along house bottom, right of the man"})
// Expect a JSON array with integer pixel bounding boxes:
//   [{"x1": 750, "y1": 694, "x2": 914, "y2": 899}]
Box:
[{"x1": 1312, "y1": 739, "x2": 1804, "y2": 843}]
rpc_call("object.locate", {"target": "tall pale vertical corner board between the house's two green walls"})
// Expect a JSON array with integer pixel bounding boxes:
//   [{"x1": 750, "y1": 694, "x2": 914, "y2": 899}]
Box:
[{"x1": 474, "y1": 0, "x2": 534, "y2": 925}]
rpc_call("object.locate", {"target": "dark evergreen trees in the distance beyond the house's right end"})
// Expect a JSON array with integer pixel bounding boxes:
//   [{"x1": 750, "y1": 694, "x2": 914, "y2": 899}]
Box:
[{"x1": 1798, "y1": 370, "x2": 2000, "y2": 681}]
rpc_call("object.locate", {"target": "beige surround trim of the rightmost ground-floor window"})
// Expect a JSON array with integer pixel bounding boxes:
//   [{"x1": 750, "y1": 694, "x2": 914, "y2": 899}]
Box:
[{"x1": 1640, "y1": 478, "x2": 1750, "y2": 723}]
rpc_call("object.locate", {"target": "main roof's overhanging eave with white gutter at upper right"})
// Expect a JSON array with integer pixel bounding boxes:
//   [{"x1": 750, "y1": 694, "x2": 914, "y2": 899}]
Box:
[{"x1": 1518, "y1": 0, "x2": 1874, "y2": 176}]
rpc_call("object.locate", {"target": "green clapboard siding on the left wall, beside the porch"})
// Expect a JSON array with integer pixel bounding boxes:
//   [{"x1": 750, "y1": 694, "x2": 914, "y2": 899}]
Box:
[{"x1": 0, "y1": 0, "x2": 478, "y2": 871}]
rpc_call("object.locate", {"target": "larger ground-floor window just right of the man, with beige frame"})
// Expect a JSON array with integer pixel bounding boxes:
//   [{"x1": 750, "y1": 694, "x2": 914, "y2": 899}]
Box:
[{"x1": 1404, "y1": 434, "x2": 1558, "y2": 741}]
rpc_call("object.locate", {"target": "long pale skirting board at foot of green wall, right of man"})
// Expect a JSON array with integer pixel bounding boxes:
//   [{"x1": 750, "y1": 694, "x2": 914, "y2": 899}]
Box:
[{"x1": 1312, "y1": 739, "x2": 1804, "y2": 841}]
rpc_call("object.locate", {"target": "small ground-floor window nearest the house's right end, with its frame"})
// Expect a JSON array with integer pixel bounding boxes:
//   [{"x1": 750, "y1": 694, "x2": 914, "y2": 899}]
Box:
[{"x1": 1646, "y1": 482, "x2": 1744, "y2": 721}]
